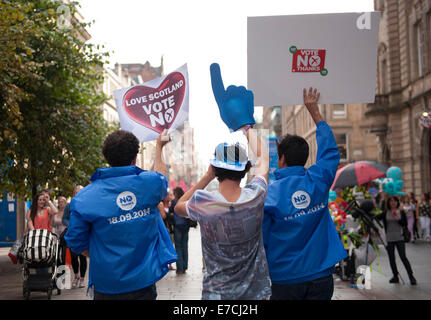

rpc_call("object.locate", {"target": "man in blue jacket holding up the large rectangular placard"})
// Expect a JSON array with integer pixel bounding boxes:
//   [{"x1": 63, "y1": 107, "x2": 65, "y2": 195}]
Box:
[{"x1": 263, "y1": 88, "x2": 347, "y2": 300}]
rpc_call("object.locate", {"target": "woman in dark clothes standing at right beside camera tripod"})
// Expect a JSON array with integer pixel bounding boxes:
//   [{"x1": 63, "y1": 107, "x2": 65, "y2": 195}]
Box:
[{"x1": 376, "y1": 196, "x2": 417, "y2": 285}]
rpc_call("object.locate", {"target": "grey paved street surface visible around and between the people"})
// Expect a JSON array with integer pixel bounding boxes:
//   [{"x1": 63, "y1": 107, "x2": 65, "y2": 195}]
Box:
[{"x1": 0, "y1": 229, "x2": 431, "y2": 300}]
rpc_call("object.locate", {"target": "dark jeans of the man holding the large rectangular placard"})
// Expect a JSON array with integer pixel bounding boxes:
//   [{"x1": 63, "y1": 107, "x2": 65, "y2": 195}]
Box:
[{"x1": 271, "y1": 274, "x2": 334, "y2": 300}]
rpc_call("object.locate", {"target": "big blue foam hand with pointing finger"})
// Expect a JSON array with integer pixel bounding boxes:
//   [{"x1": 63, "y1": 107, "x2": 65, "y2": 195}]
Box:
[{"x1": 210, "y1": 63, "x2": 256, "y2": 131}]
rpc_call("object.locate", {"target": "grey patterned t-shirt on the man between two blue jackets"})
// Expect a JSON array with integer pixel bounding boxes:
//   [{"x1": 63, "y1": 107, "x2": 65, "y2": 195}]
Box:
[{"x1": 187, "y1": 176, "x2": 271, "y2": 300}]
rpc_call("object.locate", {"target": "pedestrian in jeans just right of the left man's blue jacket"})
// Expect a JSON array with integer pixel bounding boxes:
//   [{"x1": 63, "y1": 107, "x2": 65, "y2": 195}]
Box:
[{"x1": 169, "y1": 187, "x2": 190, "y2": 274}]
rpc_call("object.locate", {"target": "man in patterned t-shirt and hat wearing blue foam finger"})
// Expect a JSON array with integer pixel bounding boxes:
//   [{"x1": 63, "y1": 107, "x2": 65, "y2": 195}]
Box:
[{"x1": 175, "y1": 64, "x2": 271, "y2": 300}]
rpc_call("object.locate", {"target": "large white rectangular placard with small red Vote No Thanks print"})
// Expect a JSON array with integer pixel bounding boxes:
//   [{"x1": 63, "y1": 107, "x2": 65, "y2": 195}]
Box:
[{"x1": 247, "y1": 12, "x2": 380, "y2": 106}]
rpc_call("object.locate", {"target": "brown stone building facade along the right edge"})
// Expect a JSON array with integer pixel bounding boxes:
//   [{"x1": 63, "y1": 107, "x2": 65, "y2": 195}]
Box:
[{"x1": 365, "y1": 0, "x2": 431, "y2": 194}]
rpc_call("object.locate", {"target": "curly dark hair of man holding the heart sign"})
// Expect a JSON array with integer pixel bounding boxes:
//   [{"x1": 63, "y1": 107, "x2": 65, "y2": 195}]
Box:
[{"x1": 102, "y1": 130, "x2": 139, "y2": 167}]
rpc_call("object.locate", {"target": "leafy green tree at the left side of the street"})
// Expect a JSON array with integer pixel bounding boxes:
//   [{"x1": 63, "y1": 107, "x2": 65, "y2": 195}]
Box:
[{"x1": 0, "y1": 0, "x2": 112, "y2": 197}]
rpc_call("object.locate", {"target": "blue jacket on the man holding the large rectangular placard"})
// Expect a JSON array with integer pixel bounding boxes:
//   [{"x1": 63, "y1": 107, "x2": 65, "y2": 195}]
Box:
[{"x1": 263, "y1": 121, "x2": 347, "y2": 284}]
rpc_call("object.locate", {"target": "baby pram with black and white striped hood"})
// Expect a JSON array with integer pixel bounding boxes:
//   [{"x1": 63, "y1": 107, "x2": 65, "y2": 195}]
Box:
[{"x1": 22, "y1": 229, "x2": 61, "y2": 300}]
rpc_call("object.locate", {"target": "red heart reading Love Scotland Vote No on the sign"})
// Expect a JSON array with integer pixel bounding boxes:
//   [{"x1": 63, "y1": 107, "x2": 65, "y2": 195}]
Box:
[{"x1": 123, "y1": 72, "x2": 186, "y2": 133}]
